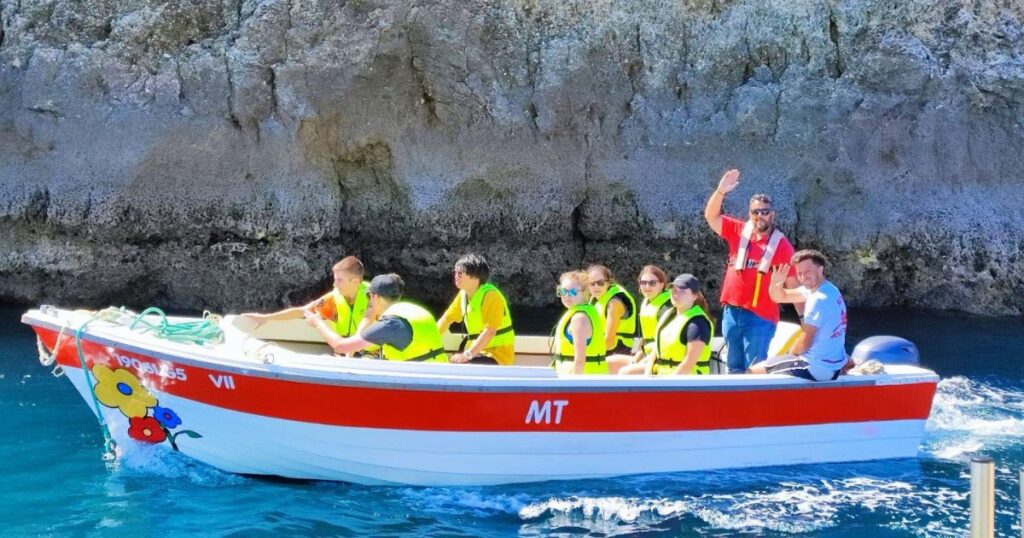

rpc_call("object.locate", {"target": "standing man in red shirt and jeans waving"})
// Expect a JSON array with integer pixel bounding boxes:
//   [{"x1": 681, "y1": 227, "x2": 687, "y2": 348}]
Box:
[{"x1": 705, "y1": 170, "x2": 799, "y2": 374}]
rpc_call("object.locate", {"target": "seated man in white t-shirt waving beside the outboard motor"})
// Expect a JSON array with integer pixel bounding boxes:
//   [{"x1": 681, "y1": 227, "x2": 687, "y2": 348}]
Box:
[{"x1": 748, "y1": 250, "x2": 847, "y2": 381}]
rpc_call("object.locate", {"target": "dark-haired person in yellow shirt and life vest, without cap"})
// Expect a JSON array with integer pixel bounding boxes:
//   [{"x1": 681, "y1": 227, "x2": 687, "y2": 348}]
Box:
[{"x1": 437, "y1": 254, "x2": 515, "y2": 366}]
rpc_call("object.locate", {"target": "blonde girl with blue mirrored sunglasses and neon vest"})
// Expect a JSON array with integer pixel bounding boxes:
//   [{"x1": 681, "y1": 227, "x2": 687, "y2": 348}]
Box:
[{"x1": 552, "y1": 271, "x2": 608, "y2": 374}]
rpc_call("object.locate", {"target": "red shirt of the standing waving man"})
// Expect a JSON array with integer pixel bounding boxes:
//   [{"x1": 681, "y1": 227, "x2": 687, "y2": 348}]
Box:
[{"x1": 721, "y1": 215, "x2": 797, "y2": 323}]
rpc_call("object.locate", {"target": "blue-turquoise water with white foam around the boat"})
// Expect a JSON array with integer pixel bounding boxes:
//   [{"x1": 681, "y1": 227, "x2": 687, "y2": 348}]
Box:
[{"x1": 0, "y1": 308, "x2": 1024, "y2": 537}]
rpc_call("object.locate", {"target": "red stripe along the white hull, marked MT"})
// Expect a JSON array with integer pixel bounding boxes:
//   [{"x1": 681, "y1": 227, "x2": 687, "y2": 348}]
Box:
[{"x1": 35, "y1": 327, "x2": 936, "y2": 431}]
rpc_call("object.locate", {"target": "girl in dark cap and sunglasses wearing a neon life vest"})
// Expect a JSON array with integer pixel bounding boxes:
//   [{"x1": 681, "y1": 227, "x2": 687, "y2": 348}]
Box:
[{"x1": 620, "y1": 275, "x2": 715, "y2": 375}]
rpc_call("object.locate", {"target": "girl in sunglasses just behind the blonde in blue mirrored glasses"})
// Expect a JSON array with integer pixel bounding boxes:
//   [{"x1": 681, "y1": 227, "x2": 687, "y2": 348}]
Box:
[{"x1": 587, "y1": 264, "x2": 637, "y2": 355}]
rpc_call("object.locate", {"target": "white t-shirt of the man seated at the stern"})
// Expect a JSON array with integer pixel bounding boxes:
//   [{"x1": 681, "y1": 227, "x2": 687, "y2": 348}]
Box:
[{"x1": 798, "y1": 280, "x2": 847, "y2": 371}]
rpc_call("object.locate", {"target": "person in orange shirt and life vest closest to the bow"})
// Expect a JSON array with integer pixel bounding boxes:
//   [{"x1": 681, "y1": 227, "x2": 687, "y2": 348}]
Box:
[{"x1": 242, "y1": 256, "x2": 369, "y2": 336}]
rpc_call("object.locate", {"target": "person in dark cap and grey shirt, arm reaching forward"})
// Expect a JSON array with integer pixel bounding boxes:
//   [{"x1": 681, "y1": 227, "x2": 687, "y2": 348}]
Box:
[{"x1": 305, "y1": 273, "x2": 447, "y2": 363}]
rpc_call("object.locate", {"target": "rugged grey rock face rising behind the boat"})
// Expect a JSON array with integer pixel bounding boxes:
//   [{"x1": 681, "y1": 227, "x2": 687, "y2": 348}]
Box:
[{"x1": 0, "y1": 0, "x2": 1024, "y2": 314}]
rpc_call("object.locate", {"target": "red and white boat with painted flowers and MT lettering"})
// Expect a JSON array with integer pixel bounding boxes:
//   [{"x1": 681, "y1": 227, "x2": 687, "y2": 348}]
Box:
[{"x1": 23, "y1": 307, "x2": 938, "y2": 486}]
